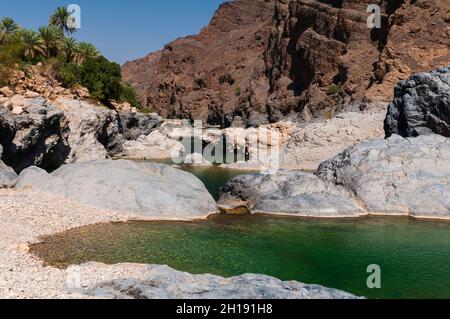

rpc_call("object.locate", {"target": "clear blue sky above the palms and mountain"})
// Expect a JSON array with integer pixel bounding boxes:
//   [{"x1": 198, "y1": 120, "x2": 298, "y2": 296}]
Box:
[{"x1": 0, "y1": 0, "x2": 225, "y2": 64}]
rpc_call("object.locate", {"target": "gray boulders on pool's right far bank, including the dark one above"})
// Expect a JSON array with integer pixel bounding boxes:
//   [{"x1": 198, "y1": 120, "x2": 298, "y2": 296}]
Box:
[{"x1": 219, "y1": 68, "x2": 450, "y2": 219}]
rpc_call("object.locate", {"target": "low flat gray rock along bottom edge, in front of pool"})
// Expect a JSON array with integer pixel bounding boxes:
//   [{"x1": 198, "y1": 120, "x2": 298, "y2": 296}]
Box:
[{"x1": 74, "y1": 263, "x2": 357, "y2": 299}]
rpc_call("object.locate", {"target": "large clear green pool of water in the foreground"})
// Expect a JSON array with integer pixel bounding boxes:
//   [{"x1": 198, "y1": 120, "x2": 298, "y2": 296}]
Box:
[{"x1": 31, "y1": 216, "x2": 450, "y2": 298}]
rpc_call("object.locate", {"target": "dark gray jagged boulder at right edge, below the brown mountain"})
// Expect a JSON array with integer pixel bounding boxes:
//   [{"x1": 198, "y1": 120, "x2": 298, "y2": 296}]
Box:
[{"x1": 384, "y1": 68, "x2": 450, "y2": 137}]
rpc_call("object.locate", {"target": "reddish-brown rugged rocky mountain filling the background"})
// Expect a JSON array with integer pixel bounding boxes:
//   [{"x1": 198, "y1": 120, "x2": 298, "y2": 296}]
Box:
[{"x1": 122, "y1": 0, "x2": 450, "y2": 126}]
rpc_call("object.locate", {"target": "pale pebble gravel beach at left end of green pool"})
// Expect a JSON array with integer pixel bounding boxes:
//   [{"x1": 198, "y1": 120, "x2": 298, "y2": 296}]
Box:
[{"x1": 0, "y1": 189, "x2": 134, "y2": 299}]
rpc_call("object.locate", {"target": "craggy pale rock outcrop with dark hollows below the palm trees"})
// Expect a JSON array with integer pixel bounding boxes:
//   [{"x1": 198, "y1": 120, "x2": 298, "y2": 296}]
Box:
[{"x1": 0, "y1": 94, "x2": 162, "y2": 173}]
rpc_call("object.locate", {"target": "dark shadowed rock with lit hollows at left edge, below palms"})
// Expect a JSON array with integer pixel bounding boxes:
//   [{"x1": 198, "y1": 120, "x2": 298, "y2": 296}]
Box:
[{"x1": 0, "y1": 98, "x2": 69, "y2": 172}]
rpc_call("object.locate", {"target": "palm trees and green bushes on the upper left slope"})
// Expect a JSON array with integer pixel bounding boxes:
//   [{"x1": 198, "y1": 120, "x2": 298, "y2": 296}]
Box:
[{"x1": 0, "y1": 7, "x2": 140, "y2": 107}]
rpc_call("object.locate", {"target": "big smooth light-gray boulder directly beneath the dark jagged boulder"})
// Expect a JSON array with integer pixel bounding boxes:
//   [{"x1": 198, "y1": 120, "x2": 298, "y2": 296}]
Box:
[{"x1": 317, "y1": 135, "x2": 450, "y2": 218}]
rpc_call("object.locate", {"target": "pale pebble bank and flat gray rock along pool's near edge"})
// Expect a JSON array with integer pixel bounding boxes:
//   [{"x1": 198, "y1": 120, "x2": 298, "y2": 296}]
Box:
[{"x1": 0, "y1": 189, "x2": 356, "y2": 299}]
